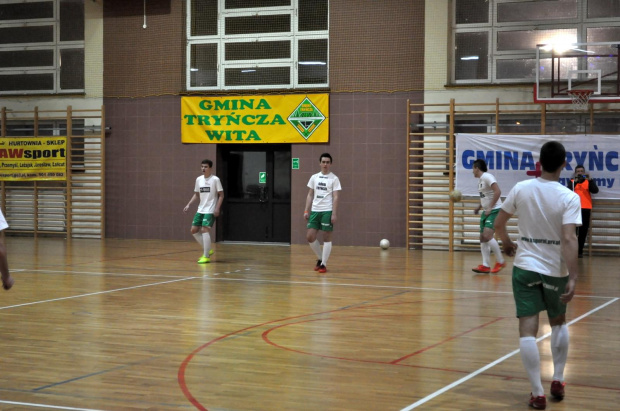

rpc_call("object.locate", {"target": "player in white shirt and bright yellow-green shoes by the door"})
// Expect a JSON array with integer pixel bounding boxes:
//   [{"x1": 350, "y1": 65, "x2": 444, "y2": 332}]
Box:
[{"x1": 183, "y1": 160, "x2": 224, "y2": 264}]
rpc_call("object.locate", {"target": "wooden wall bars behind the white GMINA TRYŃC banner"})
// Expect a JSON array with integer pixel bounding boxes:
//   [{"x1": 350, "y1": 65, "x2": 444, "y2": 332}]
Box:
[{"x1": 407, "y1": 99, "x2": 620, "y2": 255}]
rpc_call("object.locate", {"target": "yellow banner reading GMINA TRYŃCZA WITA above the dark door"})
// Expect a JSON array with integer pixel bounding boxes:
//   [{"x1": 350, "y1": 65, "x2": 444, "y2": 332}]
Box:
[{"x1": 181, "y1": 94, "x2": 329, "y2": 144}]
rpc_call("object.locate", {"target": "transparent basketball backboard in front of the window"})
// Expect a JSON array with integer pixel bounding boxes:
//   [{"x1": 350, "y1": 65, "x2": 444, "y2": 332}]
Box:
[{"x1": 534, "y1": 40, "x2": 620, "y2": 104}]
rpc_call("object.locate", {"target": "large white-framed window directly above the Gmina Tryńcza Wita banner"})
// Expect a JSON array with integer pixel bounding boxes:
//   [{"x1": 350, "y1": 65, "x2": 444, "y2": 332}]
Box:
[{"x1": 186, "y1": 0, "x2": 329, "y2": 90}]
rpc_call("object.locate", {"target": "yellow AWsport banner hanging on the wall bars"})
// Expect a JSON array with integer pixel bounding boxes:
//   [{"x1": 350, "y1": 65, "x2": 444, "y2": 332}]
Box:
[{"x1": 0, "y1": 137, "x2": 67, "y2": 181}]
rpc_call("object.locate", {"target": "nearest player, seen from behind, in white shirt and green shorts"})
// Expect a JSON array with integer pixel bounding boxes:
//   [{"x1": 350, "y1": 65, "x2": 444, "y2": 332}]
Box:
[{"x1": 495, "y1": 141, "x2": 581, "y2": 410}]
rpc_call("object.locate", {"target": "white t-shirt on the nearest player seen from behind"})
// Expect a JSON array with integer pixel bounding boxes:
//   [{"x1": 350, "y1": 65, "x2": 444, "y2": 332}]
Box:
[{"x1": 502, "y1": 178, "x2": 581, "y2": 277}]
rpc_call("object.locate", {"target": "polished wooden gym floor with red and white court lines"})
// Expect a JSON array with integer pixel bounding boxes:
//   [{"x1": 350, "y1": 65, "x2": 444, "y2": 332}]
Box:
[{"x1": 0, "y1": 237, "x2": 620, "y2": 411}]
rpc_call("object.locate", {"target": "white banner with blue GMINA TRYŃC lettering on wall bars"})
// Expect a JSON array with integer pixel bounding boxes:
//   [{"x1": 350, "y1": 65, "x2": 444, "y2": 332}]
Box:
[{"x1": 456, "y1": 134, "x2": 620, "y2": 199}]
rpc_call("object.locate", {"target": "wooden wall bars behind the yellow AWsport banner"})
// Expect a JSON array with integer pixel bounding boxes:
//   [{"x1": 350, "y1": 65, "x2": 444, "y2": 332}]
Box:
[{"x1": 0, "y1": 106, "x2": 105, "y2": 238}]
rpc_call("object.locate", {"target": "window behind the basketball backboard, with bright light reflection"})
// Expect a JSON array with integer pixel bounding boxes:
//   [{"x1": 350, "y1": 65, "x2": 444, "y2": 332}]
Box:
[{"x1": 452, "y1": 0, "x2": 620, "y2": 84}]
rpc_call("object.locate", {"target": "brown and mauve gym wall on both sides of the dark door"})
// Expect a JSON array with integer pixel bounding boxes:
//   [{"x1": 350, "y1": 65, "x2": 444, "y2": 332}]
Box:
[{"x1": 104, "y1": 0, "x2": 424, "y2": 247}]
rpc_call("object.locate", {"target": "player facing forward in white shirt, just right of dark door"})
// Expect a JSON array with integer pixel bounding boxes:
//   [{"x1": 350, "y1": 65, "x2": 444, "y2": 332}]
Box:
[{"x1": 304, "y1": 153, "x2": 342, "y2": 273}]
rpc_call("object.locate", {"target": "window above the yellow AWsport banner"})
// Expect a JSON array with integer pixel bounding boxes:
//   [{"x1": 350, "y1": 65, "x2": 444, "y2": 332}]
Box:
[{"x1": 0, "y1": 0, "x2": 84, "y2": 95}]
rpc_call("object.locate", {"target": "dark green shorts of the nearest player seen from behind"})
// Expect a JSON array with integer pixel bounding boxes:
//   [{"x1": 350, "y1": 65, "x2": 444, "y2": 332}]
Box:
[{"x1": 512, "y1": 266, "x2": 568, "y2": 318}]
